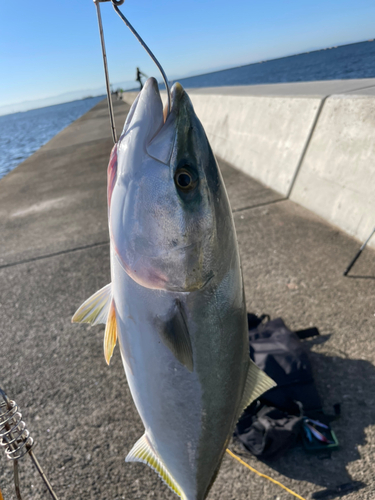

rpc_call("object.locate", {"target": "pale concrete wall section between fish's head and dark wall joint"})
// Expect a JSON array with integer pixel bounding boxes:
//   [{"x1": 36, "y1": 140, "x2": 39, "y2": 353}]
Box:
[{"x1": 190, "y1": 93, "x2": 321, "y2": 195}]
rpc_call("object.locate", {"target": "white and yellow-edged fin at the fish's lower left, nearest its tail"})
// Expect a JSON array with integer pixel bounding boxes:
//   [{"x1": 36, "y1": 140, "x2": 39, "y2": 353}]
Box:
[{"x1": 125, "y1": 434, "x2": 186, "y2": 500}]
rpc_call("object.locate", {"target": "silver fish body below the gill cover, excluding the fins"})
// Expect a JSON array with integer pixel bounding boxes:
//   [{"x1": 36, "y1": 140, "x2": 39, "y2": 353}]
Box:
[{"x1": 112, "y1": 252, "x2": 248, "y2": 500}]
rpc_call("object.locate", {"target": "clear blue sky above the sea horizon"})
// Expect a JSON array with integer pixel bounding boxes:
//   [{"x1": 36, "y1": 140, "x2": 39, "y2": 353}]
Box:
[{"x1": 0, "y1": 0, "x2": 375, "y2": 114}]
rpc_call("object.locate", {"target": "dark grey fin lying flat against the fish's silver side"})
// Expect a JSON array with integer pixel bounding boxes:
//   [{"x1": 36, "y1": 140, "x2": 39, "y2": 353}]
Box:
[{"x1": 159, "y1": 299, "x2": 194, "y2": 372}]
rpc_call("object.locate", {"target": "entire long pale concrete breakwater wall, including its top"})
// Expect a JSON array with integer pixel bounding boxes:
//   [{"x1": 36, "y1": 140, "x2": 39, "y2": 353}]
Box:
[{"x1": 123, "y1": 79, "x2": 375, "y2": 247}]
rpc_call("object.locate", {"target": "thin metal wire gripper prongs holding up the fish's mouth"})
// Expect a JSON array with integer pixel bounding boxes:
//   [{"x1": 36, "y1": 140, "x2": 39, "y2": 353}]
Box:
[{"x1": 94, "y1": 0, "x2": 171, "y2": 144}]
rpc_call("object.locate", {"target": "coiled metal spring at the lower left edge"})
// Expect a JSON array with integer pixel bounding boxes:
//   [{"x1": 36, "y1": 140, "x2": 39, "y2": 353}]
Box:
[{"x1": 0, "y1": 389, "x2": 34, "y2": 460}]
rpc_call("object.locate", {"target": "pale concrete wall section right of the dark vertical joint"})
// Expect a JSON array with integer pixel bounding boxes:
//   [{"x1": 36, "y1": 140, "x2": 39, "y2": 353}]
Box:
[{"x1": 291, "y1": 95, "x2": 375, "y2": 247}]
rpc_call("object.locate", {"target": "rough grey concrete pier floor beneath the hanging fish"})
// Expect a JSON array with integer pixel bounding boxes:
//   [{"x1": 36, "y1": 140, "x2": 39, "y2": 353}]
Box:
[{"x1": 0, "y1": 95, "x2": 375, "y2": 500}]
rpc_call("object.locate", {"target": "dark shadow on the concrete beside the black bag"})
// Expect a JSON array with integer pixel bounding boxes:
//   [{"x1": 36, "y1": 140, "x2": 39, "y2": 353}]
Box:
[{"x1": 236, "y1": 332, "x2": 375, "y2": 499}]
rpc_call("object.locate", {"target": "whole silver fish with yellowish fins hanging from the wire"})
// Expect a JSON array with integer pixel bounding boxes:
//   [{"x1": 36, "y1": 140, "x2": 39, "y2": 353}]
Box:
[{"x1": 72, "y1": 78, "x2": 276, "y2": 500}]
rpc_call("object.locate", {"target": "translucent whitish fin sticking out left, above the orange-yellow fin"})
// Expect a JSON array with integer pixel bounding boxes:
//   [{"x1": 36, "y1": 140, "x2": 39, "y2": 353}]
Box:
[{"x1": 72, "y1": 283, "x2": 112, "y2": 325}]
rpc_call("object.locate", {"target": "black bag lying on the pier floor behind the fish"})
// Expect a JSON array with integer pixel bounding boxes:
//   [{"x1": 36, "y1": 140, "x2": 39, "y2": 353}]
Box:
[{"x1": 235, "y1": 315, "x2": 322, "y2": 459}]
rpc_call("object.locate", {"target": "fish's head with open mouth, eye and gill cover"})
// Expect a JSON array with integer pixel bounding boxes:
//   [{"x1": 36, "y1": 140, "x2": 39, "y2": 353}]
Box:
[{"x1": 108, "y1": 78, "x2": 233, "y2": 292}]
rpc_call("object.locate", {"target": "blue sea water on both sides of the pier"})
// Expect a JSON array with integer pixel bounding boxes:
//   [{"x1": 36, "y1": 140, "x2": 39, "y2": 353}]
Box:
[{"x1": 0, "y1": 40, "x2": 375, "y2": 181}]
